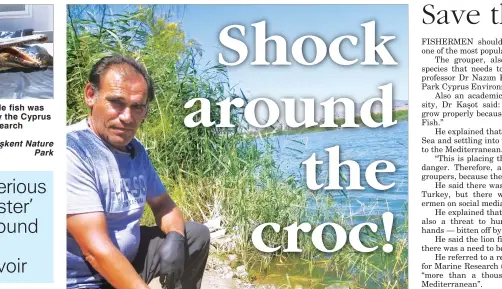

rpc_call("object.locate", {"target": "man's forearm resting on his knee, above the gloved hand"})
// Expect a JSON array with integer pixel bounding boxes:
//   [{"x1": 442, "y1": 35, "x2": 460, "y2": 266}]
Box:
[{"x1": 148, "y1": 193, "x2": 185, "y2": 236}]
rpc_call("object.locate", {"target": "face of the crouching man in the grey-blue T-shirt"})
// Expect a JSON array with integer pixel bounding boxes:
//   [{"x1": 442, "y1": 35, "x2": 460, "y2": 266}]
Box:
[{"x1": 85, "y1": 65, "x2": 148, "y2": 150}]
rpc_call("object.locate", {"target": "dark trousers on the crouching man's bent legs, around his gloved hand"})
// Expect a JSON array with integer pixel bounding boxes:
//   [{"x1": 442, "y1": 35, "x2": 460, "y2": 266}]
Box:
[{"x1": 103, "y1": 222, "x2": 210, "y2": 289}]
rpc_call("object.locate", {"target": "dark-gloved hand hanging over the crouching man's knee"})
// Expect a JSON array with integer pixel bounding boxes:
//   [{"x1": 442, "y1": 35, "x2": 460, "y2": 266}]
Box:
[{"x1": 159, "y1": 231, "x2": 186, "y2": 288}]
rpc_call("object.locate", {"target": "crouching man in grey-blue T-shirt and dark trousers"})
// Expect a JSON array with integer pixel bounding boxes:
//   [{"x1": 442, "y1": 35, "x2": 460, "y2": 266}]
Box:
[{"x1": 66, "y1": 55, "x2": 209, "y2": 289}]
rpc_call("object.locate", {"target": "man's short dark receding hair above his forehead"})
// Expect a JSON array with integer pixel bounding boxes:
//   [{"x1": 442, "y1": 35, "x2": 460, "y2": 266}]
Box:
[{"x1": 89, "y1": 54, "x2": 155, "y2": 102}]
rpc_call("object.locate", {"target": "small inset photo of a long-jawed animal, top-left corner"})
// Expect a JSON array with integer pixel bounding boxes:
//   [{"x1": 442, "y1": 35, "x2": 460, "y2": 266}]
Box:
[{"x1": 0, "y1": 4, "x2": 54, "y2": 99}]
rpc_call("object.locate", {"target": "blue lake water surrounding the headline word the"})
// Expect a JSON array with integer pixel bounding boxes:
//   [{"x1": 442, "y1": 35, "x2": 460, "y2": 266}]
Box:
[{"x1": 270, "y1": 122, "x2": 408, "y2": 220}]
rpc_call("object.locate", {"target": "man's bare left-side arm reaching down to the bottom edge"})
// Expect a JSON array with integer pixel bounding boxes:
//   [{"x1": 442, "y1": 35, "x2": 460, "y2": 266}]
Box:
[{"x1": 66, "y1": 212, "x2": 148, "y2": 289}]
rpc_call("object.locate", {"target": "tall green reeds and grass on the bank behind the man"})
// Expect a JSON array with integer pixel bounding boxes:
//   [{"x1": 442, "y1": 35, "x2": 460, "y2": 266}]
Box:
[{"x1": 67, "y1": 5, "x2": 407, "y2": 289}]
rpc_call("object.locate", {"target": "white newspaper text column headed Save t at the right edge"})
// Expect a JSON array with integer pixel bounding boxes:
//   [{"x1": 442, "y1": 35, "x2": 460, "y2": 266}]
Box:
[{"x1": 409, "y1": 1, "x2": 502, "y2": 288}]
